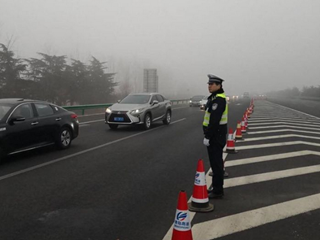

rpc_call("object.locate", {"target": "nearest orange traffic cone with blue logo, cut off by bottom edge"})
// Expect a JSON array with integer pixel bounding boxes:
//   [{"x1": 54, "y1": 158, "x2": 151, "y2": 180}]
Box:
[{"x1": 171, "y1": 190, "x2": 192, "y2": 240}]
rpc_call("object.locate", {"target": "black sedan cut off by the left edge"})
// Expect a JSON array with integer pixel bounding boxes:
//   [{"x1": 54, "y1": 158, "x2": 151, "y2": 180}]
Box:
[{"x1": 0, "y1": 98, "x2": 79, "y2": 160}]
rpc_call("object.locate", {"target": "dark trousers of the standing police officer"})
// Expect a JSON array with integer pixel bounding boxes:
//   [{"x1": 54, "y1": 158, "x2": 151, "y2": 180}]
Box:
[{"x1": 207, "y1": 143, "x2": 224, "y2": 194}]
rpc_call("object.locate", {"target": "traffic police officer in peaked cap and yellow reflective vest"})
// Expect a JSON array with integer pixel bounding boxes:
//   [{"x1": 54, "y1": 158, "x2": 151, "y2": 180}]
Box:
[{"x1": 203, "y1": 74, "x2": 228, "y2": 198}]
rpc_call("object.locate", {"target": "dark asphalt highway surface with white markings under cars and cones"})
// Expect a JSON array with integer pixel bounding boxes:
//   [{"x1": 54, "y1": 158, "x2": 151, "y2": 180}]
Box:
[{"x1": 0, "y1": 98, "x2": 320, "y2": 240}]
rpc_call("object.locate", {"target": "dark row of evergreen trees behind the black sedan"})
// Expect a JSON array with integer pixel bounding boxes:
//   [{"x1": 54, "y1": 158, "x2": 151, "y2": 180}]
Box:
[{"x1": 0, "y1": 43, "x2": 117, "y2": 105}]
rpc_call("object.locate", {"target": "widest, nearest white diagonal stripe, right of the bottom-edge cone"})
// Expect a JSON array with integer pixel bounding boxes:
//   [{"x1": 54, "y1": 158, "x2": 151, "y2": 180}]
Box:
[{"x1": 192, "y1": 194, "x2": 320, "y2": 240}]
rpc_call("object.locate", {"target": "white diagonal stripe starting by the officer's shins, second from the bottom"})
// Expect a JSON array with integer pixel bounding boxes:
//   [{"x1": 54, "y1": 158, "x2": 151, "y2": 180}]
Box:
[{"x1": 223, "y1": 165, "x2": 320, "y2": 188}]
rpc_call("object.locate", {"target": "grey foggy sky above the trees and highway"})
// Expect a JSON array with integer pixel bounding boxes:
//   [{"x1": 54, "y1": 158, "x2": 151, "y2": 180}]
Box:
[{"x1": 0, "y1": 0, "x2": 320, "y2": 96}]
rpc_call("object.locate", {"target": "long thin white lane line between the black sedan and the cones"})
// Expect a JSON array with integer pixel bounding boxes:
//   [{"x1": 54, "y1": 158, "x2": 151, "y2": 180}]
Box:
[{"x1": 0, "y1": 118, "x2": 186, "y2": 181}]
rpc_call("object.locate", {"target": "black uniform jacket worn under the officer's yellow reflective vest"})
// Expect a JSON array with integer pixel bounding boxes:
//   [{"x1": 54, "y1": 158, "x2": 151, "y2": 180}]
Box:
[{"x1": 203, "y1": 88, "x2": 227, "y2": 146}]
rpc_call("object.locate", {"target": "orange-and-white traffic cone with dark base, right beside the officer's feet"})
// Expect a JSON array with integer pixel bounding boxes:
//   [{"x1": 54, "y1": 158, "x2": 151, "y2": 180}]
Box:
[{"x1": 188, "y1": 159, "x2": 214, "y2": 212}]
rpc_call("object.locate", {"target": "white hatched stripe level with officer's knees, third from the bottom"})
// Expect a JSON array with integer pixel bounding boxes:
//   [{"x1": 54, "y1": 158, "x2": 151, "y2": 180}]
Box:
[{"x1": 225, "y1": 150, "x2": 320, "y2": 167}]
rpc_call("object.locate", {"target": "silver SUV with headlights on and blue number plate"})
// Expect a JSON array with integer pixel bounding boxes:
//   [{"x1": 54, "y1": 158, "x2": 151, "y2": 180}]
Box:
[{"x1": 105, "y1": 93, "x2": 172, "y2": 129}]
